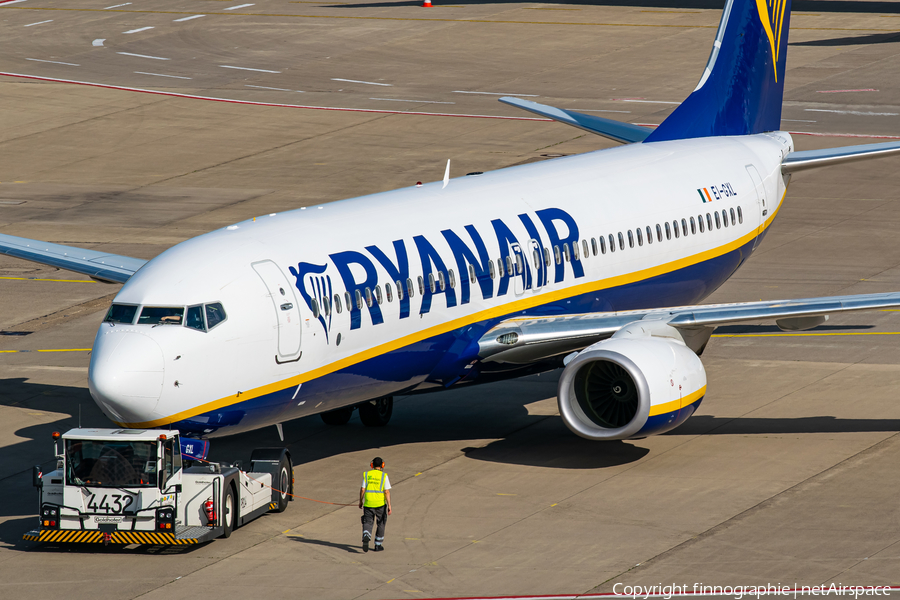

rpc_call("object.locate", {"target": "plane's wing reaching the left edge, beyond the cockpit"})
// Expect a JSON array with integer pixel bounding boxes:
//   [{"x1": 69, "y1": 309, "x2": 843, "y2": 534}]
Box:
[{"x1": 0, "y1": 234, "x2": 147, "y2": 283}]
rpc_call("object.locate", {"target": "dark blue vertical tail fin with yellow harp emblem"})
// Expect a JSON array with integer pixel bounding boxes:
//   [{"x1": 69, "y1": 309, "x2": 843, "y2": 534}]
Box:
[{"x1": 644, "y1": 0, "x2": 791, "y2": 142}]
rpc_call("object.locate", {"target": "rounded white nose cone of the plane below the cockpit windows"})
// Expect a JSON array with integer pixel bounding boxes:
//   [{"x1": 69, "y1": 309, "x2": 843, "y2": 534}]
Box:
[{"x1": 88, "y1": 327, "x2": 165, "y2": 423}]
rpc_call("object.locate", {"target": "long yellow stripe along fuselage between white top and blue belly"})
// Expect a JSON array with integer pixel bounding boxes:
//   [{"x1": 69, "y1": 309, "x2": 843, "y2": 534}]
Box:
[{"x1": 114, "y1": 188, "x2": 787, "y2": 429}]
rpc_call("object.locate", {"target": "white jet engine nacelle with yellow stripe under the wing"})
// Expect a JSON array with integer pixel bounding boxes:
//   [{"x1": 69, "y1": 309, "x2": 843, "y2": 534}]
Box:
[{"x1": 558, "y1": 326, "x2": 706, "y2": 440}]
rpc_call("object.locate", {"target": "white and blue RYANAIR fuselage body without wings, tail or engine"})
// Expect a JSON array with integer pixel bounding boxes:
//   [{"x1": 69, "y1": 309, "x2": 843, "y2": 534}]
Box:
[{"x1": 90, "y1": 132, "x2": 793, "y2": 435}]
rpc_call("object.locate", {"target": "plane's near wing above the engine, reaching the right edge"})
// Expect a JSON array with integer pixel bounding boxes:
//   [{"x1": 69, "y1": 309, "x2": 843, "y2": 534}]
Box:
[{"x1": 478, "y1": 292, "x2": 900, "y2": 364}]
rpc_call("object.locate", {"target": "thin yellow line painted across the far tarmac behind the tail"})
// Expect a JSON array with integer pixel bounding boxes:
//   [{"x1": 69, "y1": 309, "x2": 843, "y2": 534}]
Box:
[{"x1": 6, "y1": 6, "x2": 896, "y2": 32}]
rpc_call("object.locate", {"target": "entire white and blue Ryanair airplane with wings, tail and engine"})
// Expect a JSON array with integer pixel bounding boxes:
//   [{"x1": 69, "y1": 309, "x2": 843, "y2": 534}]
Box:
[{"x1": 0, "y1": 0, "x2": 900, "y2": 440}]
